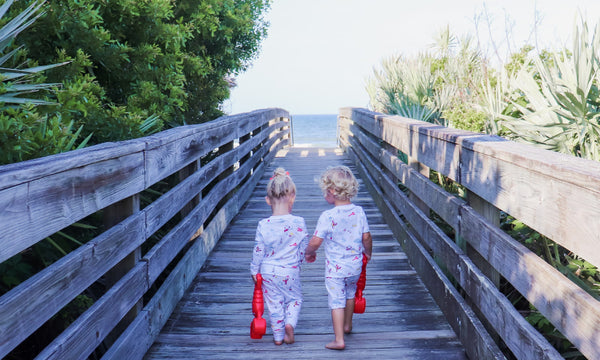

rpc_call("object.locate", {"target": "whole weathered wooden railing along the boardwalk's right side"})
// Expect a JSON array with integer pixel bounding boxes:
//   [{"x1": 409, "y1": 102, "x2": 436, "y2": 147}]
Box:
[{"x1": 338, "y1": 108, "x2": 600, "y2": 360}]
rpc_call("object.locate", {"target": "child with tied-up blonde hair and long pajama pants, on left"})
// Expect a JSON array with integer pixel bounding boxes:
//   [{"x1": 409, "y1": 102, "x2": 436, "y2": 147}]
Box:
[{"x1": 250, "y1": 168, "x2": 308, "y2": 345}]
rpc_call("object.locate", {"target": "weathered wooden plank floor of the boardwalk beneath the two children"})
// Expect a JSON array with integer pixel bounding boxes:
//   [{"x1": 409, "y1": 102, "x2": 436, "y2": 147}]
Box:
[{"x1": 145, "y1": 148, "x2": 466, "y2": 360}]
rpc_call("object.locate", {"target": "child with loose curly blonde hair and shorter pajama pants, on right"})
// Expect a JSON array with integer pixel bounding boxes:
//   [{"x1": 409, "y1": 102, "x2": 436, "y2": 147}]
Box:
[{"x1": 305, "y1": 166, "x2": 373, "y2": 350}]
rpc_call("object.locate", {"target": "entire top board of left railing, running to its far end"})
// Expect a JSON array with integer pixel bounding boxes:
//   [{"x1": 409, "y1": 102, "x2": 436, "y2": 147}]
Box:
[{"x1": 0, "y1": 109, "x2": 289, "y2": 262}]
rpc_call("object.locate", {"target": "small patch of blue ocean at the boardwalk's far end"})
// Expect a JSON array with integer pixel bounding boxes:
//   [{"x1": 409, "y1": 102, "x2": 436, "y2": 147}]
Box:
[{"x1": 292, "y1": 114, "x2": 337, "y2": 148}]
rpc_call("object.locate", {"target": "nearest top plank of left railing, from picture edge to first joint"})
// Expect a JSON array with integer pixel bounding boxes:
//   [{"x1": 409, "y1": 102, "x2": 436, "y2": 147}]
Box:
[{"x1": 0, "y1": 148, "x2": 144, "y2": 262}]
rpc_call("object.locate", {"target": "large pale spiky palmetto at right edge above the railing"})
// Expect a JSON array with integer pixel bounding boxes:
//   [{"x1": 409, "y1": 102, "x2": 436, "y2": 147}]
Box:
[{"x1": 500, "y1": 22, "x2": 600, "y2": 160}]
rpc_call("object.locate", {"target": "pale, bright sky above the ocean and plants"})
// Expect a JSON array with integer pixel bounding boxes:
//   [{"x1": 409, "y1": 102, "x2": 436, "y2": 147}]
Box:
[{"x1": 223, "y1": 0, "x2": 600, "y2": 115}]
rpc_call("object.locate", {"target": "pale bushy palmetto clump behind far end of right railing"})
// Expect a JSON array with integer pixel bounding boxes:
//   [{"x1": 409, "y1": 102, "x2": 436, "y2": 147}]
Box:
[{"x1": 367, "y1": 28, "x2": 485, "y2": 125}]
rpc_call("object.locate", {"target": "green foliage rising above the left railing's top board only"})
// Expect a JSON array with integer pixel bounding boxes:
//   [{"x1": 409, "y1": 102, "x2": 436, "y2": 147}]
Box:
[{"x1": 0, "y1": 0, "x2": 269, "y2": 163}]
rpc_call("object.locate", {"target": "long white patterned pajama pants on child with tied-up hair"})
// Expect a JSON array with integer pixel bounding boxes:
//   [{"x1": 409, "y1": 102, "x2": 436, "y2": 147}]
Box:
[{"x1": 262, "y1": 274, "x2": 302, "y2": 341}]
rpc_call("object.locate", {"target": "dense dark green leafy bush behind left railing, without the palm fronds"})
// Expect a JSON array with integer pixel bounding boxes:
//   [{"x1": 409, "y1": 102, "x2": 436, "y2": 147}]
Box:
[{"x1": 12, "y1": 0, "x2": 269, "y2": 131}]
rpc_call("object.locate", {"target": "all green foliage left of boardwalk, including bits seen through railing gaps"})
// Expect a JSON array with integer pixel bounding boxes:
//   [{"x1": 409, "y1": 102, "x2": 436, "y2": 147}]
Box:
[{"x1": 0, "y1": 0, "x2": 269, "y2": 359}]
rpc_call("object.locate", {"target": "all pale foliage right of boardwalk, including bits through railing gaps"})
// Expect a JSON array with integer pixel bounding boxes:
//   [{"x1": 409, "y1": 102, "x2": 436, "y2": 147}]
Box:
[{"x1": 367, "y1": 21, "x2": 600, "y2": 359}]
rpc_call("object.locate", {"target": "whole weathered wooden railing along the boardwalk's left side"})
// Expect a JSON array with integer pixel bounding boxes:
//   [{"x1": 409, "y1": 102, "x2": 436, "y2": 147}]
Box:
[{"x1": 0, "y1": 109, "x2": 290, "y2": 359}]
